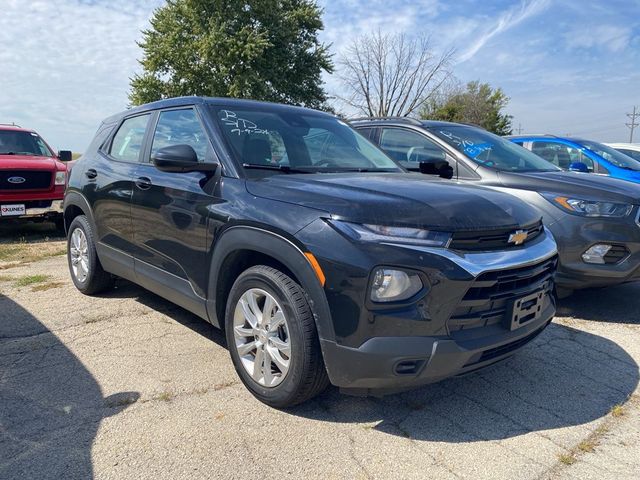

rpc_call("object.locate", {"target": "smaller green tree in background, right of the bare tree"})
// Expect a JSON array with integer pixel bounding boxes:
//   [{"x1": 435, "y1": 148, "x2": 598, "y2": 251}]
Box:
[{"x1": 420, "y1": 81, "x2": 513, "y2": 135}]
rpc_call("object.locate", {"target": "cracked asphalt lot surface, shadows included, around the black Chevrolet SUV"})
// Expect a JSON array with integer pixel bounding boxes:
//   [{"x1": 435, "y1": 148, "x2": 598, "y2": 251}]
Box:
[{"x1": 0, "y1": 246, "x2": 640, "y2": 480}]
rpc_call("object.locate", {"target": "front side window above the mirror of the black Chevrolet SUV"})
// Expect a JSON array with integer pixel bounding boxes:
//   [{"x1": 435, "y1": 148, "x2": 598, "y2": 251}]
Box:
[{"x1": 151, "y1": 108, "x2": 211, "y2": 162}]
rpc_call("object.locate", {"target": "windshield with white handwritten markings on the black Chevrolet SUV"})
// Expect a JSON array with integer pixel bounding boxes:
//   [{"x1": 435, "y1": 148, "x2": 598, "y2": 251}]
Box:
[{"x1": 212, "y1": 105, "x2": 402, "y2": 173}]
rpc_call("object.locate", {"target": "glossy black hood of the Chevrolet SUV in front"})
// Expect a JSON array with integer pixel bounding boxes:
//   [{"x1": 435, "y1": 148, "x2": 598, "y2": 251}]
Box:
[{"x1": 247, "y1": 173, "x2": 540, "y2": 232}]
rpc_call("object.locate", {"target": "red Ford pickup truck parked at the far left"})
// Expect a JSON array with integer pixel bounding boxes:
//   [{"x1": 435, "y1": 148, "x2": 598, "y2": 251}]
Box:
[{"x1": 0, "y1": 125, "x2": 71, "y2": 232}]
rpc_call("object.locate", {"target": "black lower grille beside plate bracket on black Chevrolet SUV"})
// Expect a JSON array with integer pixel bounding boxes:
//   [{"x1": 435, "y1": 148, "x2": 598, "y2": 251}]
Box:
[{"x1": 448, "y1": 257, "x2": 558, "y2": 339}]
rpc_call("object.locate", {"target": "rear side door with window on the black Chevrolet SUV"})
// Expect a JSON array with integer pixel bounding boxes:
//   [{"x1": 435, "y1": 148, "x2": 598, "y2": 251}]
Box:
[{"x1": 82, "y1": 113, "x2": 151, "y2": 258}]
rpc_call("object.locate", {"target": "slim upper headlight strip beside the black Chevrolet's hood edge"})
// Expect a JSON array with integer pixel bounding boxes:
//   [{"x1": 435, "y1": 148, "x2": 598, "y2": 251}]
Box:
[{"x1": 331, "y1": 220, "x2": 451, "y2": 247}]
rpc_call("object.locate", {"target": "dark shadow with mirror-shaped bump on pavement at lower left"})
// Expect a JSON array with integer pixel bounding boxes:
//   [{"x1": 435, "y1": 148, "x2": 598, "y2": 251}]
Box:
[{"x1": 0, "y1": 295, "x2": 139, "y2": 480}]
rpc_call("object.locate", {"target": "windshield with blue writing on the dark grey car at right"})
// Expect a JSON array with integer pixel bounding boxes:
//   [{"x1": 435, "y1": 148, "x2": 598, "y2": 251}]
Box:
[{"x1": 429, "y1": 125, "x2": 560, "y2": 172}]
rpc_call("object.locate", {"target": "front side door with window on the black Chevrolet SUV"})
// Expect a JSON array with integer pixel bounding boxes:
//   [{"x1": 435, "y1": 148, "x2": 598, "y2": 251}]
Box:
[{"x1": 131, "y1": 107, "x2": 220, "y2": 297}]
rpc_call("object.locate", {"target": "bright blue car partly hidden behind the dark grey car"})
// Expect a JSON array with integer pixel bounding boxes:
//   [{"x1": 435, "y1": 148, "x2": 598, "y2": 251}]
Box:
[{"x1": 507, "y1": 135, "x2": 640, "y2": 183}]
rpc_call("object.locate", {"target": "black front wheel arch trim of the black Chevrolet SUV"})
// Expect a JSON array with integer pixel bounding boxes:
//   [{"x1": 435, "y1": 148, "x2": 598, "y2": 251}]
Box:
[{"x1": 207, "y1": 226, "x2": 335, "y2": 340}]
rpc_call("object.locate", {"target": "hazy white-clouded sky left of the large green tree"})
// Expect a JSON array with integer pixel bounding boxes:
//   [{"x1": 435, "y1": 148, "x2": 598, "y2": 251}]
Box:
[{"x1": 0, "y1": 0, "x2": 161, "y2": 151}]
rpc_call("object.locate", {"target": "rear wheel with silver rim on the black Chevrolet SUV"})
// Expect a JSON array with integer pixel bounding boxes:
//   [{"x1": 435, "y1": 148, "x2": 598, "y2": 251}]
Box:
[{"x1": 67, "y1": 215, "x2": 113, "y2": 295}]
